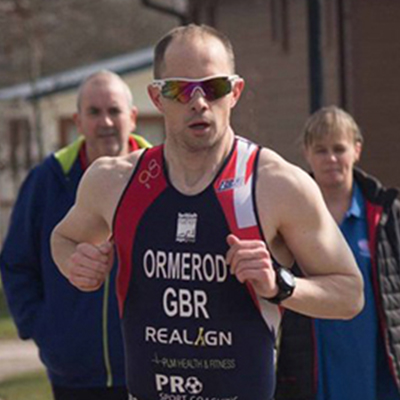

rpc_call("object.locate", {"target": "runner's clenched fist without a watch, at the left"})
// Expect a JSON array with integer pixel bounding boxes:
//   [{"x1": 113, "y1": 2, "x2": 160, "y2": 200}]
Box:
[{"x1": 68, "y1": 242, "x2": 114, "y2": 292}]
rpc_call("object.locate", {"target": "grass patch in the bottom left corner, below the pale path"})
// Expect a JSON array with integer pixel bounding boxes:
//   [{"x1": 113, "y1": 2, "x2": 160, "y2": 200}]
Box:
[{"x1": 0, "y1": 372, "x2": 53, "y2": 400}]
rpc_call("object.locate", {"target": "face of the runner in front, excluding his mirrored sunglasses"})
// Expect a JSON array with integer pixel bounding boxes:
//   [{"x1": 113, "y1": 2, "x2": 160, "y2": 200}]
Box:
[{"x1": 149, "y1": 35, "x2": 244, "y2": 152}]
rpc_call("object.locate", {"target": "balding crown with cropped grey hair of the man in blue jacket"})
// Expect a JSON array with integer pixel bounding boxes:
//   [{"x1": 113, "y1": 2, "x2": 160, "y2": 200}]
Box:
[{"x1": 76, "y1": 70, "x2": 133, "y2": 112}]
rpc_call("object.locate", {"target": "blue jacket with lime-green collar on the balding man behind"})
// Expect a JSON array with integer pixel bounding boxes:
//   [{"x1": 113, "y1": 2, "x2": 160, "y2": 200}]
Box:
[{"x1": 0, "y1": 136, "x2": 149, "y2": 387}]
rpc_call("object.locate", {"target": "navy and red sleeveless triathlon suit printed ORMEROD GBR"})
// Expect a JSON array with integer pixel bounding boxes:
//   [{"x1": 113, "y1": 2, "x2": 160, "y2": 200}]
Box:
[{"x1": 114, "y1": 138, "x2": 280, "y2": 400}]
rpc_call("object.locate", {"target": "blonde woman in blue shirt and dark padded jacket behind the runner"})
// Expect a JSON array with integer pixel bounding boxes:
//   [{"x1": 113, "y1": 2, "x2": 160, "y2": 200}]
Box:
[{"x1": 276, "y1": 106, "x2": 400, "y2": 400}]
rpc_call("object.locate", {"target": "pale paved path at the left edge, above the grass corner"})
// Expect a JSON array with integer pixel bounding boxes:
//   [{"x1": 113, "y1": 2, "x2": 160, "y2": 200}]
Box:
[{"x1": 0, "y1": 339, "x2": 43, "y2": 382}]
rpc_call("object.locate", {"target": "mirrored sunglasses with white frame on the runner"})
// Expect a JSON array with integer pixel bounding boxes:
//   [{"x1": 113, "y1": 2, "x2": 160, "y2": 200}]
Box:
[{"x1": 152, "y1": 75, "x2": 239, "y2": 104}]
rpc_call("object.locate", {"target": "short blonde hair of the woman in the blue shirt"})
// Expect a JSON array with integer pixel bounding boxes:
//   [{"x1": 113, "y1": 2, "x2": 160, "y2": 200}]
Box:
[{"x1": 302, "y1": 106, "x2": 364, "y2": 148}]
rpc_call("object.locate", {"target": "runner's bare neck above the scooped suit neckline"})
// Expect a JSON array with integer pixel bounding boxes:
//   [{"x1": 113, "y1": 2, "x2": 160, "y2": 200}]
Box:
[{"x1": 164, "y1": 128, "x2": 234, "y2": 195}]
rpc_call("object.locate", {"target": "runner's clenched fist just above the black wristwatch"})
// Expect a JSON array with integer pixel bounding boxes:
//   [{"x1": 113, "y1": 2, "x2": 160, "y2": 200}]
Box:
[{"x1": 226, "y1": 235, "x2": 278, "y2": 298}]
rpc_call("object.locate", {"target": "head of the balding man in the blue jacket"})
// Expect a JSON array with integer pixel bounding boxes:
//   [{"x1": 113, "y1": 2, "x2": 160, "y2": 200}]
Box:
[{"x1": 74, "y1": 76, "x2": 137, "y2": 163}]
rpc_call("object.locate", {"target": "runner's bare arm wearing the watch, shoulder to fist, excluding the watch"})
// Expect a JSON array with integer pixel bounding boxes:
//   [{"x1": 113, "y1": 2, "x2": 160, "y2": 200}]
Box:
[{"x1": 228, "y1": 149, "x2": 364, "y2": 319}]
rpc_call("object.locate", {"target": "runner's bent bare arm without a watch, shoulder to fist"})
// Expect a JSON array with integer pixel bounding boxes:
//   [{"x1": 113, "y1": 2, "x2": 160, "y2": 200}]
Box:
[{"x1": 51, "y1": 155, "x2": 133, "y2": 291}]
